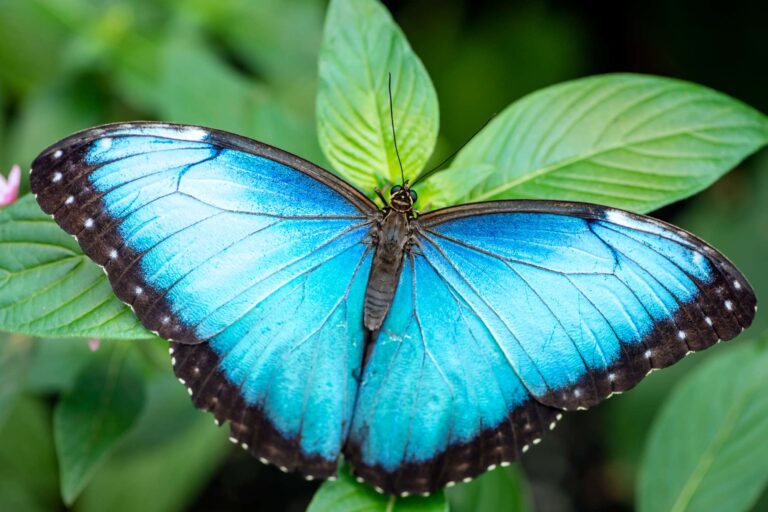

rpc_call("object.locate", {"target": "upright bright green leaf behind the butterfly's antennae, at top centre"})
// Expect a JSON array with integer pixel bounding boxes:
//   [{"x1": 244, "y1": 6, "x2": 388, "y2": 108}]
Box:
[{"x1": 317, "y1": 0, "x2": 438, "y2": 191}]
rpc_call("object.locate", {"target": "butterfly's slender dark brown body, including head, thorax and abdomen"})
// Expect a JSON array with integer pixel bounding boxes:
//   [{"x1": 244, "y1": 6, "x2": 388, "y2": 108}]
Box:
[{"x1": 363, "y1": 187, "x2": 415, "y2": 332}]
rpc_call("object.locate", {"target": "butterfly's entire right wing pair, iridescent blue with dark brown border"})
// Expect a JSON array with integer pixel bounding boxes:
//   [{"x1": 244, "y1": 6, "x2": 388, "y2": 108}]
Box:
[{"x1": 345, "y1": 201, "x2": 756, "y2": 493}]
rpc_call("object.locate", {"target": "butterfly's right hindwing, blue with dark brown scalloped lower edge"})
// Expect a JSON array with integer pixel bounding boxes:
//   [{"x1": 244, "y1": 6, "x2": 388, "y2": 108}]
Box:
[{"x1": 345, "y1": 256, "x2": 560, "y2": 495}]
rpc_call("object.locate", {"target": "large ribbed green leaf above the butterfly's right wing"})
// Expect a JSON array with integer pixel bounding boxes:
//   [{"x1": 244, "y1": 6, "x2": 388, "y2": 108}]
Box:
[{"x1": 427, "y1": 74, "x2": 768, "y2": 212}]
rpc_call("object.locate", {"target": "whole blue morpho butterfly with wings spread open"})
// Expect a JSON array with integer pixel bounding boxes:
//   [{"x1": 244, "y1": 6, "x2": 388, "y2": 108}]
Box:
[{"x1": 31, "y1": 123, "x2": 756, "y2": 495}]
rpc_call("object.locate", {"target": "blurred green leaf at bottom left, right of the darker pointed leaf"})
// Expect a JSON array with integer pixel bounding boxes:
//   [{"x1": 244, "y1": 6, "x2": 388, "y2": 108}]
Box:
[{"x1": 77, "y1": 368, "x2": 232, "y2": 512}]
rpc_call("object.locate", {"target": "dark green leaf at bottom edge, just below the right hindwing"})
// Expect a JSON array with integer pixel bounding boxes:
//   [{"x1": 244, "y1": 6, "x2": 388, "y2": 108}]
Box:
[{"x1": 446, "y1": 465, "x2": 531, "y2": 512}]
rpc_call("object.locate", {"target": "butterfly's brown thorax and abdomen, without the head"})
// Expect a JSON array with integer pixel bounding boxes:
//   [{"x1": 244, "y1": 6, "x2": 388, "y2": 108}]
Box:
[{"x1": 363, "y1": 210, "x2": 410, "y2": 331}]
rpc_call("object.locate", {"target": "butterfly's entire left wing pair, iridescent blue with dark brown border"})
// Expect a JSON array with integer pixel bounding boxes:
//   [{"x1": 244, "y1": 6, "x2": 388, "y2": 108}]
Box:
[{"x1": 30, "y1": 123, "x2": 375, "y2": 477}]
